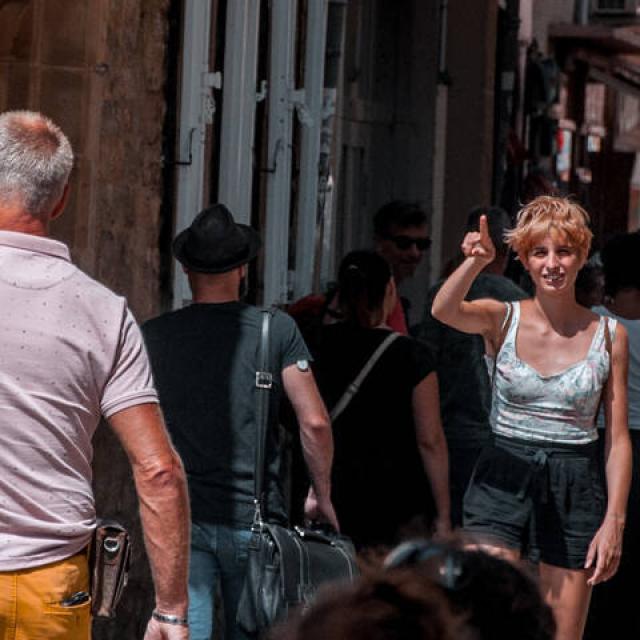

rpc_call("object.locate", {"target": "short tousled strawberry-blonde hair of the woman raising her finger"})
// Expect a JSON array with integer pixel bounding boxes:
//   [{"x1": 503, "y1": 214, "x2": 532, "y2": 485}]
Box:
[{"x1": 505, "y1": 196, "x2": 593, "y2": 257}]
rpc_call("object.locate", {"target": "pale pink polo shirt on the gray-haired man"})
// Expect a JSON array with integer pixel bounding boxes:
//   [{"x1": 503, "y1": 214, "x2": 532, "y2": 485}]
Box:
[{"x1": 0, "y1": 231, "x2": 157, "y2": 571}]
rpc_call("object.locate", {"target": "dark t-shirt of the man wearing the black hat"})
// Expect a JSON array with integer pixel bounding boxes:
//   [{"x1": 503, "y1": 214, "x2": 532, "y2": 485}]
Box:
[{"x1": 142, "y1": 302, "x2": 309, "y2": 527}]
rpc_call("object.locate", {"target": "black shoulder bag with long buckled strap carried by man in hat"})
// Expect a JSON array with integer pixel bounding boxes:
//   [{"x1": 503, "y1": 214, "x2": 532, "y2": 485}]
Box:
[{"x1": 237, "y1": 311, "x2": 358, "y2": 635}]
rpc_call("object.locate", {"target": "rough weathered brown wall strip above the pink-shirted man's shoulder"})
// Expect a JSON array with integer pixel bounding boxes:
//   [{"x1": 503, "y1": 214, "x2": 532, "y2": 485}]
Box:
[{"x1": 92, "y1": 0, "x2": 169, "y2": 319}]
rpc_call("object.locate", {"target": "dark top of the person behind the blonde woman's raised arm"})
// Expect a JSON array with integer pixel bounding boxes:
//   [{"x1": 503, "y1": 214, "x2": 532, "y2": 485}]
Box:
[{"x1": 418, "y1": 273, "x2": 529, "y2": 448}]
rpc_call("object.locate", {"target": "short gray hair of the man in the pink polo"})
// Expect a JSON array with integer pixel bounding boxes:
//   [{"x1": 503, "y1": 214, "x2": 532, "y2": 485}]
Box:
[{"x1": 0, "y1": 111, "x2": 73, "y2": 217}]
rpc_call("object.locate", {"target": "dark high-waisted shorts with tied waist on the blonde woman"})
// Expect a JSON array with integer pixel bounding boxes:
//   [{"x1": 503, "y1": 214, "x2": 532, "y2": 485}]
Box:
[{"x1": 464, "y1": 436, "x2": 605, "y2": 569}]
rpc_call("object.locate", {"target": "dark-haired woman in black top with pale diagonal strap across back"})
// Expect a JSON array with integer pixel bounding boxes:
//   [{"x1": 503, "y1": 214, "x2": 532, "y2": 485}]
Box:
[{"x1": 314, "y1": 251, "x2": 449, "y2": 548}]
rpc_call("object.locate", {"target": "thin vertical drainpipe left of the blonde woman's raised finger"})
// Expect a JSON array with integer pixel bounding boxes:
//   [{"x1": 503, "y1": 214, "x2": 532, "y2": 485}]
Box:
[{"x1": 429, "y1": 0, "x2": 450, "y2": 283}]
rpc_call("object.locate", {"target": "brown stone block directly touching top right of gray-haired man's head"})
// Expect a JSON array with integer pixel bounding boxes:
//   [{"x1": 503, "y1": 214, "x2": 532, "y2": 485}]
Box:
[{"x1": 40, "y1": 67, "x2": 89, "y2": 153}]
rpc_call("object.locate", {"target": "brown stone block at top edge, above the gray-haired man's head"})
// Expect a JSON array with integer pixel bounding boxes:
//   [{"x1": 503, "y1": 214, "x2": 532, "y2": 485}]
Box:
[{"x1": 41, "y1": 0, "x2": 88, "y2": 67}]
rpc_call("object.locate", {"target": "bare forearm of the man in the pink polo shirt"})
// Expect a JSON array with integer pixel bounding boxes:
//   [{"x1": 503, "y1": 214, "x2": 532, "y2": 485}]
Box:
[{"x1": 134, "y1": 455, "x2": 191, "y2": 617}]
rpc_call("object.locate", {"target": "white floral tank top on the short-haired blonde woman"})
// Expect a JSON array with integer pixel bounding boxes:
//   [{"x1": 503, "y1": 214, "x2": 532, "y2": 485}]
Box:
[{"x1": 486, "y1": 302, "x2": 616, "y2": 444}]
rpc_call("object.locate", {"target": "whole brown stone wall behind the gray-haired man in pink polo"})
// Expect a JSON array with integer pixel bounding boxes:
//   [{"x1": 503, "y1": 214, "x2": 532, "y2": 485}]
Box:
[{"x1": 0, "y1": 0, "x2": 174, "y2": 640}]
